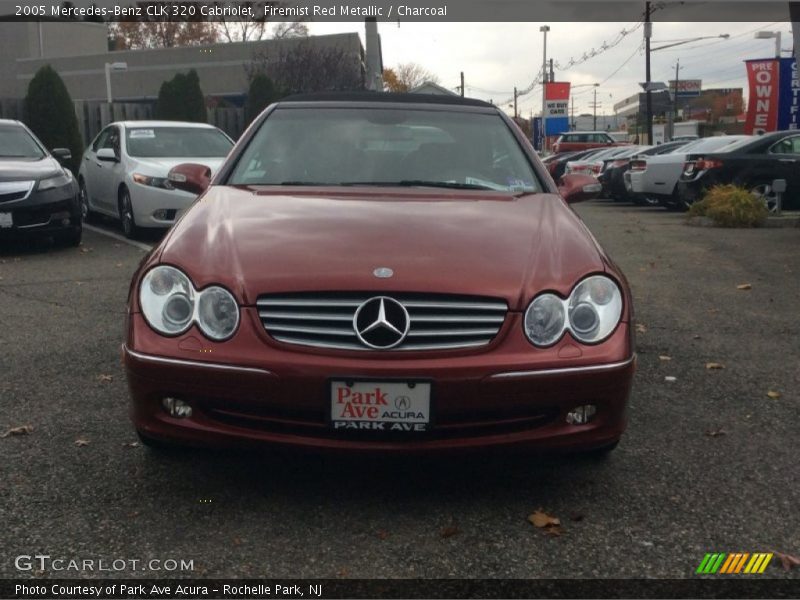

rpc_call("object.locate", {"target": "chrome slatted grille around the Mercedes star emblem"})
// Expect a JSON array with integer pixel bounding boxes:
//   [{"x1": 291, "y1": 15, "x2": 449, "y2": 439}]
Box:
[{"x1": 256, "y1": 292, "x2": 508, "y2": 351}]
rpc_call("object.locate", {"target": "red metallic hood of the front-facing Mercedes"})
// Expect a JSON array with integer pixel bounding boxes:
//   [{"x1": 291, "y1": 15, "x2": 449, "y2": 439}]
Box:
[{"x1": 160, "y1": 186, "x2": 605, "y2": 310}]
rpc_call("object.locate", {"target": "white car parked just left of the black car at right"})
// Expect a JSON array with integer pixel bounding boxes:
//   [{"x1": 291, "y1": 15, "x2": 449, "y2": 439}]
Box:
[{"x1": 630, "y1": 135, "x2": 749, "y2": 204}]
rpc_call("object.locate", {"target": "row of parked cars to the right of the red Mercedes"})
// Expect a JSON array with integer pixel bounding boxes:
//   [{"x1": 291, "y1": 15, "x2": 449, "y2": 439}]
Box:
[{"x1": 545, "y1": 130, "x2": 800, "y2": 210}]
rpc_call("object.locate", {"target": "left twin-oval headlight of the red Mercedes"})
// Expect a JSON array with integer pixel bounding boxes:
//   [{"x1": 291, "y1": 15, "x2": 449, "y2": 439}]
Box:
[{"x1": 139, "y1": 265, "x2": 239, "y2": 341}]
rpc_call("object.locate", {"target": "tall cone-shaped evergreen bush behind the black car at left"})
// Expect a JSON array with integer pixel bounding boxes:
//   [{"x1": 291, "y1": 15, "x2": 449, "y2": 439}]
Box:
[{"x1": 25, "y1": 65, "x2": 83, "y2": 173}]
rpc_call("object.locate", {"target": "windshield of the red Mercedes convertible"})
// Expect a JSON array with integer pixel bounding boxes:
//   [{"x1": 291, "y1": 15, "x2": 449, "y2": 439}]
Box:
[{"x1": 228, "y1": 107, "x2": 541, "y2": 192}]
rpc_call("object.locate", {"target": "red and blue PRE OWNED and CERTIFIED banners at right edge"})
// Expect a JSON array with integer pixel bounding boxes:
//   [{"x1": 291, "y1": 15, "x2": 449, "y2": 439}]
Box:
[{"x1": 745, "y1": 58, "x2": 800, "y2": 134}]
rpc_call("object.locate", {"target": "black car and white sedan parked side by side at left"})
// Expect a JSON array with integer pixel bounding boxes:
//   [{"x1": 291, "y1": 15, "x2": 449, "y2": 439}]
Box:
[{"x1": 0, "y1": 119, "x2": 233, "y2": 246}]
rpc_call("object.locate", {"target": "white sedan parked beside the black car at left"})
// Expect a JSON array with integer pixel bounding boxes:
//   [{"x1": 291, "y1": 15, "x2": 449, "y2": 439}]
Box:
[{"x1": 78, "y1": 121, "x2": 233, "y2": 237}]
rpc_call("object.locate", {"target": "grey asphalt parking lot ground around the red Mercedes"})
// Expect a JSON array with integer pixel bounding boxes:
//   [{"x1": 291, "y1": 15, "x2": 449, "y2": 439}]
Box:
[{"x1": 0, "y1": 202, "x2": 800, "y2": 578}]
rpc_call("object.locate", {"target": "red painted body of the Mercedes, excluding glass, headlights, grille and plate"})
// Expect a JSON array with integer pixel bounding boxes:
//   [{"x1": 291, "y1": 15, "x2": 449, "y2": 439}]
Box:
[{"x1": 122, "y1": 97, "x2": 635, "y2": 453}]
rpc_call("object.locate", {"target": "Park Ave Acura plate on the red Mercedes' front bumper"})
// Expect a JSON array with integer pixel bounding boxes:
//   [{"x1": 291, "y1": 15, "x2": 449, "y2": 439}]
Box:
[{"x1": 330, "y1": 380, "x2": 431, "y2": 433}]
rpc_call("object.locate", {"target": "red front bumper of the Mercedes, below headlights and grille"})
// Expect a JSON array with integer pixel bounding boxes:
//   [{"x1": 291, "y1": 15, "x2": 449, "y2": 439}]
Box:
[{"x1": 122, "y1": 309, "x2": 635, "y2": 452}]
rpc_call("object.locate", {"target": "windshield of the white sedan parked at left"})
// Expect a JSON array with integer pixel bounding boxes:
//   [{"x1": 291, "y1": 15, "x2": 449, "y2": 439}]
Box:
[{"x1": 125, "y1": 127, "x2": 233, "y2": 158}]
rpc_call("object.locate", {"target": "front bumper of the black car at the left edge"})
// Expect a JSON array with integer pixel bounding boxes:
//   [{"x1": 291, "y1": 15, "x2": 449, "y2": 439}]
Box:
[{"x1": 0, "y1": 186, "x2": 81, "y2": 238}]
